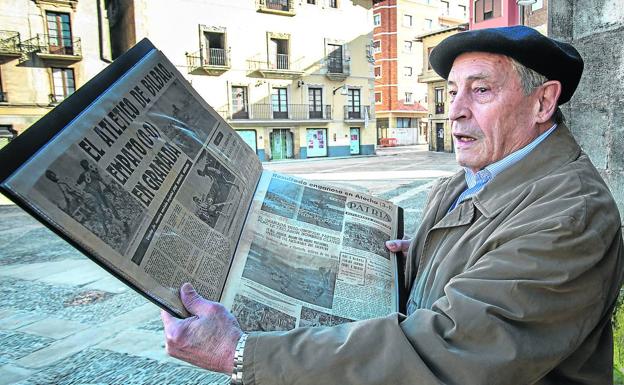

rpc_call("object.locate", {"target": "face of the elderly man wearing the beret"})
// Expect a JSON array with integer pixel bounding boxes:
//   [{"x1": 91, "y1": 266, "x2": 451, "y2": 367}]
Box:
[{"x1": 448, "y1": 52, "x2": 539, "y2": 172}]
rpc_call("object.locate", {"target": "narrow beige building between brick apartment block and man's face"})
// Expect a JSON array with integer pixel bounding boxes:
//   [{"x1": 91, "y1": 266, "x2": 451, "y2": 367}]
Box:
[{"x1": 416, "y1": 24, "x2": 468, "y2": 152}]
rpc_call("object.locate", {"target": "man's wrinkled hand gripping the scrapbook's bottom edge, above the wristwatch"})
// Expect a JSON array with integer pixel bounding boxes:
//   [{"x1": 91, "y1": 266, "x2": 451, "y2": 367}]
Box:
[{"x1": 160, "y1": 283, "x2": 242, "y2": 374}]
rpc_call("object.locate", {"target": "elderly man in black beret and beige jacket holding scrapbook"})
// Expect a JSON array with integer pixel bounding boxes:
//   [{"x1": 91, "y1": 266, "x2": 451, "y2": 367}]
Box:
[{"x1": 163, "y1": 27, "x2": 623, "y2": 385}]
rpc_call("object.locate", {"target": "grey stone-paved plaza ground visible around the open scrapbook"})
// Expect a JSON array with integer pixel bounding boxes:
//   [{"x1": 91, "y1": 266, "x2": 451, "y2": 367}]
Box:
[{"x1": 0, "y1": 146, "x2": 457, "y2": 385}]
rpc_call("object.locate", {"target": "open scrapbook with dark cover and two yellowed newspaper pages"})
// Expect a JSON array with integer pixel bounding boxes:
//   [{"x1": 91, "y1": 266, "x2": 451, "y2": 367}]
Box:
[{"x1": 0, "y1": 39, "x2": 402, "y2": 330}]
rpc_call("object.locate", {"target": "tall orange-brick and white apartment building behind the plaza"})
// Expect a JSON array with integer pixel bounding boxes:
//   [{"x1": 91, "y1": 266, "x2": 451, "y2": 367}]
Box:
[{"x1": 373, "y1": 0, "x2": 468, "y2": 144}]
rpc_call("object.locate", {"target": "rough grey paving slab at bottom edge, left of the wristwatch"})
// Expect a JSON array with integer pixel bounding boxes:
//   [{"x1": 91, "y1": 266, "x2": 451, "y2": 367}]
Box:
[{"x1": 11, "y1": 349, "x2": 230, "y2": 385}]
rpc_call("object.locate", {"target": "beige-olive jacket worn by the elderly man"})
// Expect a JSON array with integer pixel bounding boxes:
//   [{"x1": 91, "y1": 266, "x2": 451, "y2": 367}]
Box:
[{"x1": 244, "y1": 126, "x2": 624, "y2": 385}]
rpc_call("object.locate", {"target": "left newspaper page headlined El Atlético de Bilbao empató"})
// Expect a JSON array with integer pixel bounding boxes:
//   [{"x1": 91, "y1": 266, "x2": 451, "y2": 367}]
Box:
[{"x1": 7, "y1": 50, "x2": 262, "y2": 315}]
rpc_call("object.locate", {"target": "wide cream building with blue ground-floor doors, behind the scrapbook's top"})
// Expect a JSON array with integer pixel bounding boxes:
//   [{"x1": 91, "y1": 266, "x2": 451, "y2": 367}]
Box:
[{"x1": 108, "y1": 0, "x2": 376, "y2": 160}]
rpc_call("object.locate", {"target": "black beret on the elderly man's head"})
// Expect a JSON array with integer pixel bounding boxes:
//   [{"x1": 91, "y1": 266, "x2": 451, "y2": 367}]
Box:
[{"x1": 429, "y1": 25, "x2": 583, "y2": 104}]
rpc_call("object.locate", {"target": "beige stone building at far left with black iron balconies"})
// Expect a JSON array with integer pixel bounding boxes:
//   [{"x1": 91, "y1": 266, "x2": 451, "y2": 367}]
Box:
[{"x1": 0, "y1": 0, "x2": 110, "y2": 147}]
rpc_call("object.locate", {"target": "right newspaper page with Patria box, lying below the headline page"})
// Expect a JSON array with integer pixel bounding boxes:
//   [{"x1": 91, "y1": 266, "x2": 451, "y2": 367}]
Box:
[{"x1": 222, "y1": 171, "x2": 398, "y2": 331}]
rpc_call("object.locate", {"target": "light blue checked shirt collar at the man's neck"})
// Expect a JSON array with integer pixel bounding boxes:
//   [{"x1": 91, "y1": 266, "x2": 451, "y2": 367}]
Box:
[{"x1": 448, "y1": 124, "x2": 557, "y2": 212}]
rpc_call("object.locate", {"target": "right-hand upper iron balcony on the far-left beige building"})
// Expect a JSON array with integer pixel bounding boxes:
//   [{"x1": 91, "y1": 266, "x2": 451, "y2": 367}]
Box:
[{"x1": 22, "y1": 34, "x2": 82, "y2": 61}]
